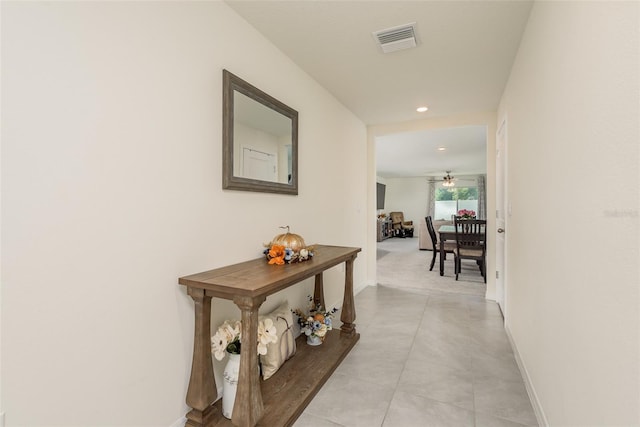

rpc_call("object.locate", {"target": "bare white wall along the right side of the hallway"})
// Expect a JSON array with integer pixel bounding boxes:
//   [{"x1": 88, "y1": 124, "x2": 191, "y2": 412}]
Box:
[{"x1": 499, "y1": 2, "x2": 640, "y2": 426}]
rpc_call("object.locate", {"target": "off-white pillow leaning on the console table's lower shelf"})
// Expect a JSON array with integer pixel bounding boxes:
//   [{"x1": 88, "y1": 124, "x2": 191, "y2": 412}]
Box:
[{"x1": 260, "y1": 301, "x2": 296, "y2": 380}]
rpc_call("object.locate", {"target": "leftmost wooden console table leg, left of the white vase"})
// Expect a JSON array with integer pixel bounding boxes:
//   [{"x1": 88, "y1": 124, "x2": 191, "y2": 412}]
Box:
[{"x1": 185, "y1": 288, "x2": 217, "y2": 427}]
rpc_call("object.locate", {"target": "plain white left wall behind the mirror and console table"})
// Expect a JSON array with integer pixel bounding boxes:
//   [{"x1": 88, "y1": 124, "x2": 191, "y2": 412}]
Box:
[{"x1": 0, "y1": 2, "x2": 368, "y2": 426}]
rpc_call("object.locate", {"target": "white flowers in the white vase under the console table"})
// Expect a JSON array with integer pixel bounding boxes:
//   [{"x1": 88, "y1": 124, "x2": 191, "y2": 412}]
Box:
[{"x1": 211, "y1": 319, "x2": 278, "y2": 360}]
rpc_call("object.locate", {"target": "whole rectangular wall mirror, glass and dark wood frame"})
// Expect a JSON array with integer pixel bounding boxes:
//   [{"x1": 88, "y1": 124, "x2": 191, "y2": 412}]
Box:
[{"x1": 222, "y1": 70, "x2": 298, "y2": 194}]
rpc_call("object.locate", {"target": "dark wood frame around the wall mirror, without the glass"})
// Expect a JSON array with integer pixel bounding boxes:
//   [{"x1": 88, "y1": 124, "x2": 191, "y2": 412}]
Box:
[{"x1": 222, "y1": 70, "x2": 298, "y2": 195}]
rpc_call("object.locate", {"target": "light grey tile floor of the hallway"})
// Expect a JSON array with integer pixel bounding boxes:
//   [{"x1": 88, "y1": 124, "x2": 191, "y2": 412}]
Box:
[{"x1": 295, "y1": 251, "x2": 537, "y2": 427}]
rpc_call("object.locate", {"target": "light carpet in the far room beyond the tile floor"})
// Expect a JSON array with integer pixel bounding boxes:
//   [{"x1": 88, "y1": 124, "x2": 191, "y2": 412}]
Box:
[{"x1": 377, "y1": 238, "x2": 486, "y2": 296}]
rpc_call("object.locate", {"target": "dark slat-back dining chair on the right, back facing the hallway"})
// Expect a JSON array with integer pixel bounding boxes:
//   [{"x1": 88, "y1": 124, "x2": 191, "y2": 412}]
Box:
[{"x1": 454, "y1": 218, "x2": 487, "y2": 283}]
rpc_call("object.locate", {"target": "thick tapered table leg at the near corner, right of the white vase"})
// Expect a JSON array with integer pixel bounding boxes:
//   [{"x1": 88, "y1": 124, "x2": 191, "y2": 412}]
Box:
[{"x1": 231, "y1": 296, "x2": 266, "y2": 427}]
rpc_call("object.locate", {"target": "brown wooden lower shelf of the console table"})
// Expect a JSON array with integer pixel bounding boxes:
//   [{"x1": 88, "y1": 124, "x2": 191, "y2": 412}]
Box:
[{"x1": 213, "y1": 330, "x2": 360, "y2": 427}]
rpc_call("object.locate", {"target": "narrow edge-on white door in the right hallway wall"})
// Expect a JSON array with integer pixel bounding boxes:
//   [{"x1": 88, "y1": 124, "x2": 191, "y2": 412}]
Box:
[{"x1": 496, "y1": 119, "x2": 508, "y2": 317}]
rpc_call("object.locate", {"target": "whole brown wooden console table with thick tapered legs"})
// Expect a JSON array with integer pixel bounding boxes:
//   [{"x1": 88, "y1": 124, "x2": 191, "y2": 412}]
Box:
[{"x1": 179, "y1": 245, "x2": 360, "y2": 427}]
